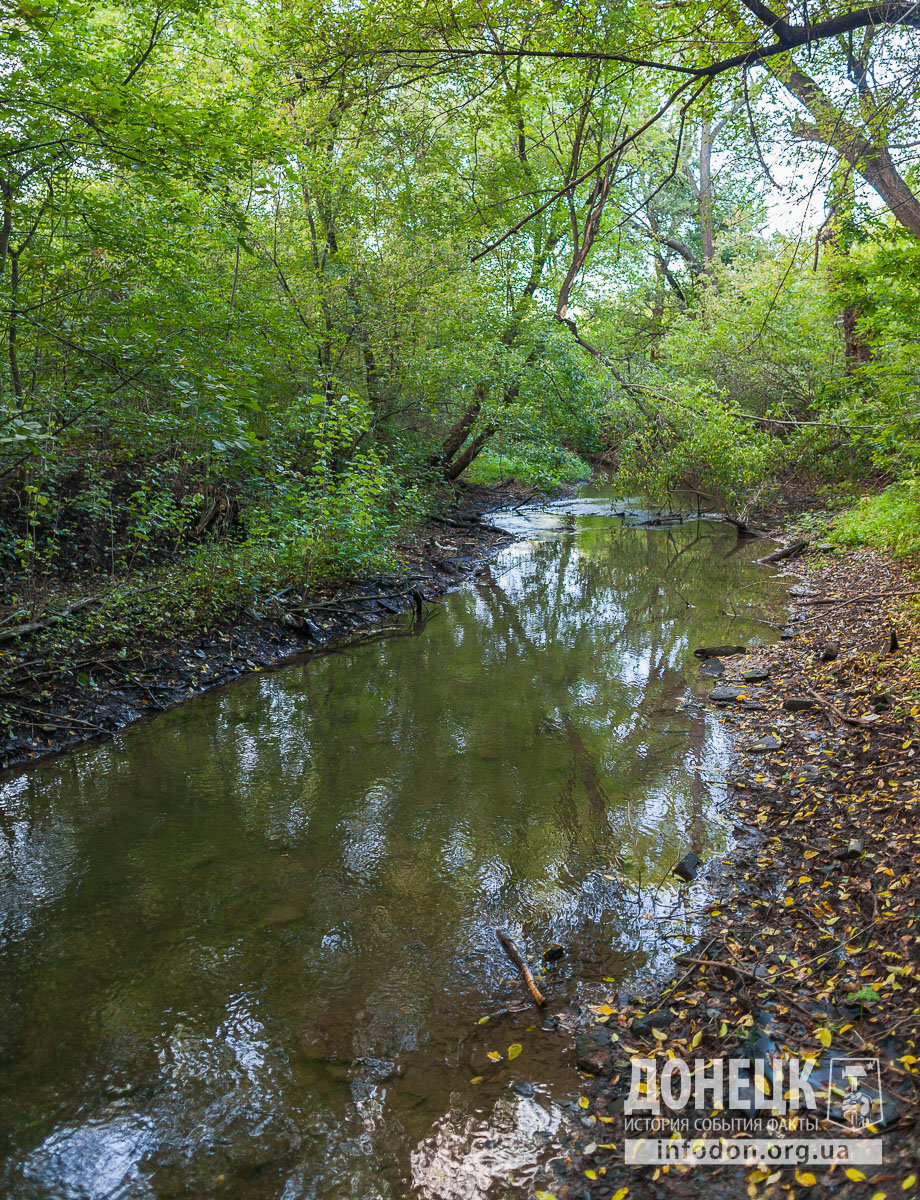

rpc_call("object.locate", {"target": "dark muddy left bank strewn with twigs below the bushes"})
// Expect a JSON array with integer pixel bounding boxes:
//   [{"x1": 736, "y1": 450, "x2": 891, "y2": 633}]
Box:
[{"x1": 0, "y1": 481, "x2": 546, "y2": 768}]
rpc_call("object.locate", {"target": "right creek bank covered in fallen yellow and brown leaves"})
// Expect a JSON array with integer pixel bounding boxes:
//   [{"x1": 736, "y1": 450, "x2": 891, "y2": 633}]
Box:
[{"x1": 539, "y1": 550, "x2": 920, "y2": 1200}]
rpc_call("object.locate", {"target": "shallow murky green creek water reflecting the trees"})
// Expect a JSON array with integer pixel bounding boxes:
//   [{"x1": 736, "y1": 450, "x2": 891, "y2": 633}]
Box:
[{"x1": 0, "y1": 484, "x2": 783, "y2": 1200}]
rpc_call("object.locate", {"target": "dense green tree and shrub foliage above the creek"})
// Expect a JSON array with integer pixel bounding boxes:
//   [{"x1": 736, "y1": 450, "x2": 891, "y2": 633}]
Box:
[{"x1": 0, "y1": 0, "x2": 920, "y2": 643}]
